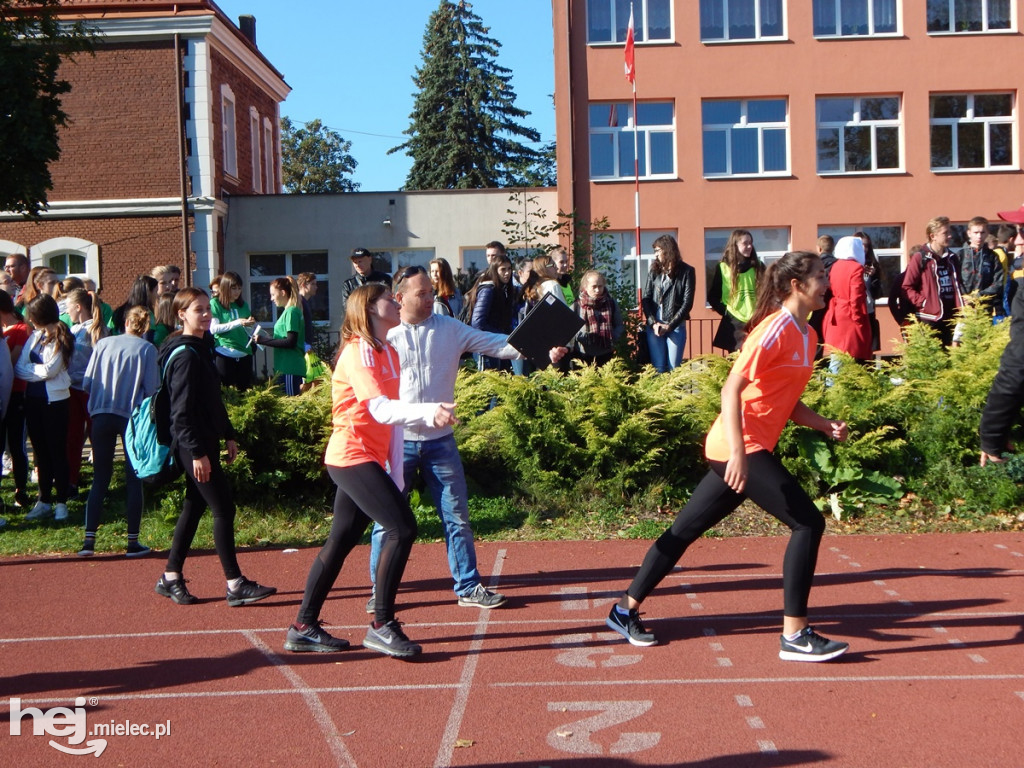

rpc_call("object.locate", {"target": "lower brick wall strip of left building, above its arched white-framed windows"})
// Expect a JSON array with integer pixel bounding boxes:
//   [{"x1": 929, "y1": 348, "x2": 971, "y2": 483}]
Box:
[{"x1": 0, "y1": 216, "x2": 181, "y2": 306}]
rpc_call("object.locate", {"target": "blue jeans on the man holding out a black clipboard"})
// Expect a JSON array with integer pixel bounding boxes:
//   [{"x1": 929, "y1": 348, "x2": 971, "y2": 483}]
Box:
[{"x1": 370, "y1": 434, "x2": 480, "y2": 596}]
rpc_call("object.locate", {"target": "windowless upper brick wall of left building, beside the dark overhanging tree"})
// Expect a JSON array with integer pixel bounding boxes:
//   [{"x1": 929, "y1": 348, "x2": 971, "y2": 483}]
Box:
[{"x1": 49, "y1": 41, "x2": 180, "y2": 202}]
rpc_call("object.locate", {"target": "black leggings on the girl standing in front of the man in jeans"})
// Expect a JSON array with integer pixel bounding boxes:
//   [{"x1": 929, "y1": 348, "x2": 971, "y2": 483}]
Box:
[{"x1": 297, "y1": 462, "x2": 416, "y2": 624}]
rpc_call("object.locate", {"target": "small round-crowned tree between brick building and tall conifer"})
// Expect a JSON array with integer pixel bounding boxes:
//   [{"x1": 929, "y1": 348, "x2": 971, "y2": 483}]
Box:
[{"x1": 281, "y1": 118, "x2": 359, "y2": 194}]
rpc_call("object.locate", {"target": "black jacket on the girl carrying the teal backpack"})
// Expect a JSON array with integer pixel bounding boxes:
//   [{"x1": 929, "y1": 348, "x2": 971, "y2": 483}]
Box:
[{"x1": 160, "y1": 334, "x2": 234, "y2": 459}]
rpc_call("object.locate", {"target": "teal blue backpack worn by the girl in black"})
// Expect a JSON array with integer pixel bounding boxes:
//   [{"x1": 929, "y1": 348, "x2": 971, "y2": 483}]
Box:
[{"x1": 125, "y1": 345, "x2": 196, "y2": 485}]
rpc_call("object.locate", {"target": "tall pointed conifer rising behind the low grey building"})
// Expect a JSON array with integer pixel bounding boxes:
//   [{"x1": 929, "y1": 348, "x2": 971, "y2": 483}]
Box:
[{"x1": 388, "y1": 0, "x2": 540, "y2": 189}]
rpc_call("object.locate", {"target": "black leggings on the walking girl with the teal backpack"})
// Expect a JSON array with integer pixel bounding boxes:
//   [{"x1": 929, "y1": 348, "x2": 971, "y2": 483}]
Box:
[{"x1": 167, "y1": 447, "x2": 242, "y2": 581}]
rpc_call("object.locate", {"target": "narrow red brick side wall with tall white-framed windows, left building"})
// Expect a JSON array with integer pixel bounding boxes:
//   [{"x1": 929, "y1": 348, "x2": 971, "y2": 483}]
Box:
[{"x1": 210, "y1": 50, "x2": 279, "y2": 195}]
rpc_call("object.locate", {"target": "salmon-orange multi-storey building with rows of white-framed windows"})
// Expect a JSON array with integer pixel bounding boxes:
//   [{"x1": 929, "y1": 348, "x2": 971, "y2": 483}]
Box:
[{"x1": 552, "y1": 0, "x2": 1024, "y2": 354}]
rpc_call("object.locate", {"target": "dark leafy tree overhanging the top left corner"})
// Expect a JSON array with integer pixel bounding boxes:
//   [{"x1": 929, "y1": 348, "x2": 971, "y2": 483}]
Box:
[{"x1": 0, "y1": 0, "x2": 91, "y2": 216}]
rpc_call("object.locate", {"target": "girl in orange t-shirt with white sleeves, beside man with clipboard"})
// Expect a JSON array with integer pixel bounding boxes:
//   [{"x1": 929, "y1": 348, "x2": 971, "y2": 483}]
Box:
[{"x1": 285, "y1": 283, "x2": 455, "y2": 656}]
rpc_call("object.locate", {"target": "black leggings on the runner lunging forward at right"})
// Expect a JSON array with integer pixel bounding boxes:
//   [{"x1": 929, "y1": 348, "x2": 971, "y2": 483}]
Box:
[{"x1": 626, "y1": 451, "x2": 825, "y2": 617}]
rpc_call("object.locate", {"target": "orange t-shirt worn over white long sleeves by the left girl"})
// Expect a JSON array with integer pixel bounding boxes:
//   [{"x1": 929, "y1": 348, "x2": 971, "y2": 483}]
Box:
[{"x1": 324, "y1": 338, "x2": 400, "y2": 467}]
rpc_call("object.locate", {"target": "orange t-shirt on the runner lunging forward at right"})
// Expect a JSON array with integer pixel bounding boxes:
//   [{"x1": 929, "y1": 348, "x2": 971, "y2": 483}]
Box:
[{"x1": 705, "y1": 309, "x2": 818, "y2": 462}]
